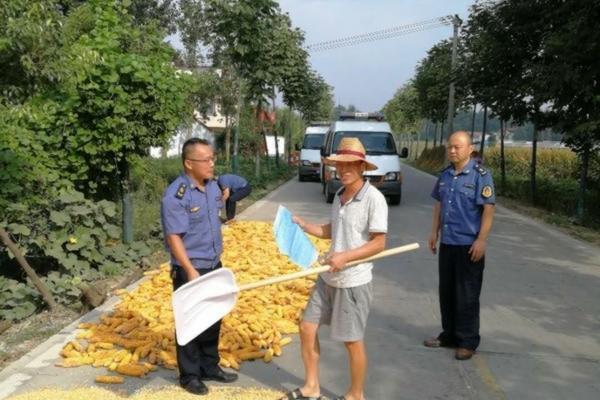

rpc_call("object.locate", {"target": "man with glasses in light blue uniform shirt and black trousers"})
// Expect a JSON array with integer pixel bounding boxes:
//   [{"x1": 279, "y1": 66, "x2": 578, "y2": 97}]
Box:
[{"x1": 161, "y1": 138, "x2": 237, "y2": 394}]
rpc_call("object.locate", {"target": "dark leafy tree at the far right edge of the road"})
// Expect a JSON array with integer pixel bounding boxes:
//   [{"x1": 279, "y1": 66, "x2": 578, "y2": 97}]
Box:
[{"x1": 538, "y1": 0, "x2": 600, "y2": 223}]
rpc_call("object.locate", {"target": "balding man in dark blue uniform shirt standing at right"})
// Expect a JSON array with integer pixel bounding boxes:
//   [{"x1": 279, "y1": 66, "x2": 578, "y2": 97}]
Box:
[{"x1": 424, "y1": 131, "x2": 496, "y2": 360}]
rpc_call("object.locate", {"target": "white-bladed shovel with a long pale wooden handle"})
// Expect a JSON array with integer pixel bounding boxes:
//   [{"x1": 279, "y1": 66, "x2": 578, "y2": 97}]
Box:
[{"x1": 173, "y1": 243, "x2": 419, "y2": 346}]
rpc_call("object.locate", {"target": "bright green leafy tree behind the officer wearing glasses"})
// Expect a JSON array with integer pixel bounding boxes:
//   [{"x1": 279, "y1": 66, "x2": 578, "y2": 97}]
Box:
[{"x1": 39, "y1": 0, "x2": 196, "y2": 242}]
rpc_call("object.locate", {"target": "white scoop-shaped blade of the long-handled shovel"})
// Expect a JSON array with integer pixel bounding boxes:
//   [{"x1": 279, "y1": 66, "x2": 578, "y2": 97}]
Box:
[{"x1": 173, "y1": 268, "x2": 238, "y2": 346}]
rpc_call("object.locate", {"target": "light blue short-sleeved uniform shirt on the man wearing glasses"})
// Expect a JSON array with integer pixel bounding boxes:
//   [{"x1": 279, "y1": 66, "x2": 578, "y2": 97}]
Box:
[{"x1": 160, "y1": 174, "x2": 223, "y2": 268}]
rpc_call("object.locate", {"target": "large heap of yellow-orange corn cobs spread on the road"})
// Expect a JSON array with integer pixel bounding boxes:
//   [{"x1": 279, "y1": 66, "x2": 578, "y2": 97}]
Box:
[{"x1": 56, "y1": 222, "x2": 329, "y2": 383}]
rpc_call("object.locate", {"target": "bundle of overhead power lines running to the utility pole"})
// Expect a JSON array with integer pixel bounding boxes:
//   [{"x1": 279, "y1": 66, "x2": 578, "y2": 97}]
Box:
[{"x1": 306, "y1": 15, "x2": 453, "y2": 52}]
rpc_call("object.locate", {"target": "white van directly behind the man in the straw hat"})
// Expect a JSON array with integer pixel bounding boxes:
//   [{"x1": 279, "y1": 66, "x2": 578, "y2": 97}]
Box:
[{"x1": 321, "y1": 113, "x2": 408, "y2": 205}]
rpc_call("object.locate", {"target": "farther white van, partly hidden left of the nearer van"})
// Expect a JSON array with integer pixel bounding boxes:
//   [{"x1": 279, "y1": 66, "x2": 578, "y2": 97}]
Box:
[{"x1": 298, "y1": 122, "x2": 329, "y2": 182}]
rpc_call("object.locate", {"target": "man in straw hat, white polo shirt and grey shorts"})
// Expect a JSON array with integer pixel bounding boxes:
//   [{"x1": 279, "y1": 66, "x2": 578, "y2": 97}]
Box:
[{"x1": 282, "y1": 137, "x2": 388, "y2": 400}]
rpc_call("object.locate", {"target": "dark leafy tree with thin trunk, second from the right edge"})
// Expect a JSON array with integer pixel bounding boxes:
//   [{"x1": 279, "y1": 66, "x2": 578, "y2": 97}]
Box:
[{"x1": 463, "y1": 0, "x2": 554, "y2": 203}]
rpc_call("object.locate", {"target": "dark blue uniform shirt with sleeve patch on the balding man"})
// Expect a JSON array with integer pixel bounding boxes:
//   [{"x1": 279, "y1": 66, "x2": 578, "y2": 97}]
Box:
[{"x1": 431, "y1": 160, "x2": 496, "y2": 246}]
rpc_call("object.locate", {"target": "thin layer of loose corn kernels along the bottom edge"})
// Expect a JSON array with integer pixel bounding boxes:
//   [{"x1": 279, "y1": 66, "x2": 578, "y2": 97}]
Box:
[{"x1": 9, "y1": 387, "x2": 282, "y2": 400}]
